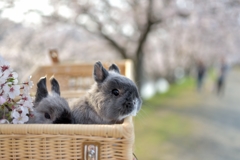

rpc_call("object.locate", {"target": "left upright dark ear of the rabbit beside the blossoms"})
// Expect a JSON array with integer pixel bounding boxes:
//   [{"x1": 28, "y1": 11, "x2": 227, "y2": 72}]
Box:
[{"x1": 35, "y1": 77, "x2": 48, "y2": 102}]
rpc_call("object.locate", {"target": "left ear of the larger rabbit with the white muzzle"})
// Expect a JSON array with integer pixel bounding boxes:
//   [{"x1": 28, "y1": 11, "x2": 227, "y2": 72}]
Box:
[{"x1": 93, "y1": 61, "x2": 108, "y2": 83}]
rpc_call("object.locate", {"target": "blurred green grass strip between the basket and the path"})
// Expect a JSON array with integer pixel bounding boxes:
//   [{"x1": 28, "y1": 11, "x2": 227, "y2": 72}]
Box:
[{"x1": 134, "y1": 78, "x2": 195, "y2": 160}]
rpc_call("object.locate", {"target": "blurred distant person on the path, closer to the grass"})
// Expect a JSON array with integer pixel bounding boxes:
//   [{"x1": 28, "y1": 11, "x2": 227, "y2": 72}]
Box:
[{"x1": 197, "y1": 60, "x2": 206, "y2": 92}]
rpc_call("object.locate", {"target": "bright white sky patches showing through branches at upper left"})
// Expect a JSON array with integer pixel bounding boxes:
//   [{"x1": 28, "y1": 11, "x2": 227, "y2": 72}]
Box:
[{"x1": 0, "y1": 0, "x2": 131, "y2": 24}]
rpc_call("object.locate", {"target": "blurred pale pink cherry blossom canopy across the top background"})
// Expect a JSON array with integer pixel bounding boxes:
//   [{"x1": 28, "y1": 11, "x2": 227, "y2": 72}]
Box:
[{"x1": 0, "y1": 0, "x2": 240, "y2": 86}]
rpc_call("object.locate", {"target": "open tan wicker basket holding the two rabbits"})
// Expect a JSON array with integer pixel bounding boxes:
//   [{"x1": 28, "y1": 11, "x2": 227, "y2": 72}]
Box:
[{"x1": 0, "y1": 60, "x2": 134, "y2": 160}]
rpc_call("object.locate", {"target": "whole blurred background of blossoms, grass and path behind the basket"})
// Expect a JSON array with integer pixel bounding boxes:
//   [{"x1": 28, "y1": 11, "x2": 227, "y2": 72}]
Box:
[{"x1": 0, "y1": 0, "x2": 240, "y2": 160}]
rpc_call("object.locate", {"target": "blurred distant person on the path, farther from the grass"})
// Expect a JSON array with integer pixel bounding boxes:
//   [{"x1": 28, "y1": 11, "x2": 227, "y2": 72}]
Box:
[{"x1": 216, "y1": 58, "x2": 228, "y2": 95}]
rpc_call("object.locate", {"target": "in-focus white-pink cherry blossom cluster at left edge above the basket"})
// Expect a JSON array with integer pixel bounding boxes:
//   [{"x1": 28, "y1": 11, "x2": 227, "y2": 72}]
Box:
[{"x1": 0, "y1": 57, "x2": 33, "y2": 124}]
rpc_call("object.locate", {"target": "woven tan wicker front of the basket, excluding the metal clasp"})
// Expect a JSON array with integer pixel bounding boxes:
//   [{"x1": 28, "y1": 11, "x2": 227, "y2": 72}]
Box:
[{"x1": 0, "y1": 117, "x2": 134, "y2": 160}]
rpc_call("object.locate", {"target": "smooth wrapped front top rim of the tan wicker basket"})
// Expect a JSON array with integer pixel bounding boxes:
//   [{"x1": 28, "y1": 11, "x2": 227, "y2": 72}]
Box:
[{"x1": 0, "y1": 117, "x2": 134, "y2": 137}]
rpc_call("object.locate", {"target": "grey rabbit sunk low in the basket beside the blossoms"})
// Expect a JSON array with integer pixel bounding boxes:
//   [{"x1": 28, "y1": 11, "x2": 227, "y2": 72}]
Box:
[{"x1": 28, "y1": 77, "x2": 72, "y2": 124}]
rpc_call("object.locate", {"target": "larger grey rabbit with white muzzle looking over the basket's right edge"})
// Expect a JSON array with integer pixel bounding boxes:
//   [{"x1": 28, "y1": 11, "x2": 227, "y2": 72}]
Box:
[{"x1": 72, "y1": 62, "x2": 142, "y2": 124}]
